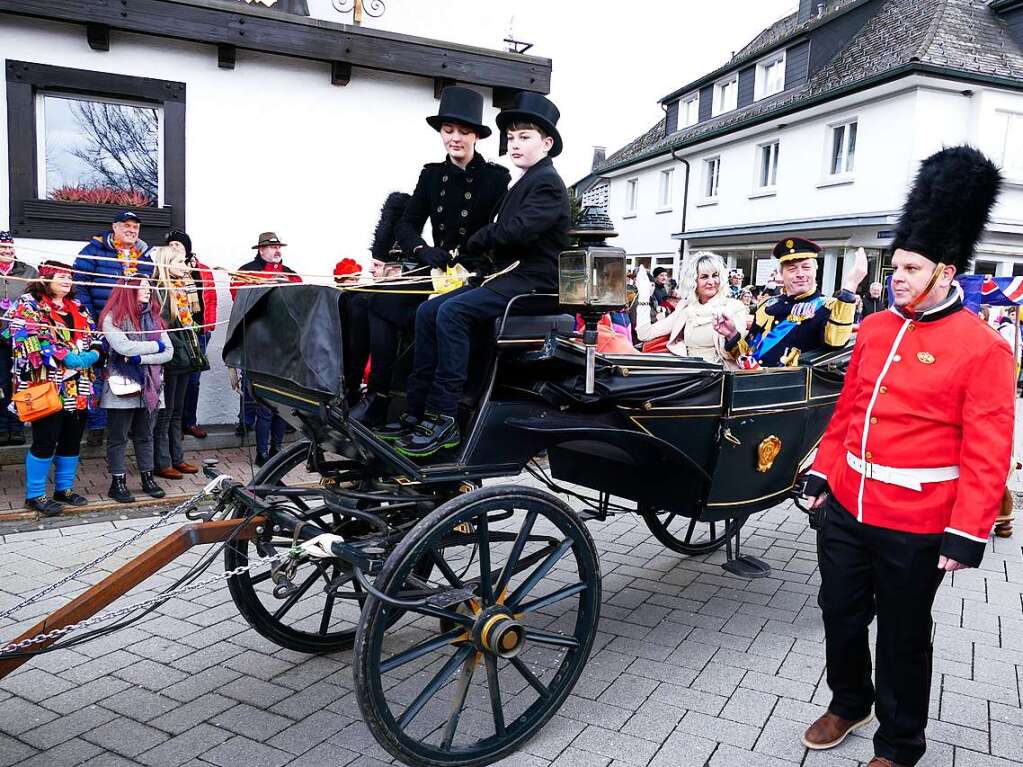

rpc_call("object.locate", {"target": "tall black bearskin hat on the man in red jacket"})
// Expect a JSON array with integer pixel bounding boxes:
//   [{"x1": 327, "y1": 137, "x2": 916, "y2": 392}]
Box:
[{"x1": 892, "y1": 146, "x2": 1002, "y2": 274}]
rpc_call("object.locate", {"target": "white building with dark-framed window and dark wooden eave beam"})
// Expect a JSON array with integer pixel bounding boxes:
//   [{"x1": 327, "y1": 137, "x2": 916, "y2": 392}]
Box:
[{"x1": 0, "y1": 0, "x2": 551, "y2": 422}]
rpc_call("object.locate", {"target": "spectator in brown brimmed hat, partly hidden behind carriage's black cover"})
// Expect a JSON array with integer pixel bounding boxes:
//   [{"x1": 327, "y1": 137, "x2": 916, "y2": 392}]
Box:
[{"x1": 231, "y1": 232, "x2": 302, "y2": 466}]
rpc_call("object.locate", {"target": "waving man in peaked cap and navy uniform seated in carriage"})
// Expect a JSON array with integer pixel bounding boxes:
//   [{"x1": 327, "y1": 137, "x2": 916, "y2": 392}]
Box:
[{"x1": 715, "y1": 237, "x2": 868, "y2": 367}]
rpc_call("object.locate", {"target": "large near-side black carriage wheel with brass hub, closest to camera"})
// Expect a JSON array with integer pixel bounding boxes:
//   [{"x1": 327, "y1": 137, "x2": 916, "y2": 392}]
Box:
[{"x1": 354, "y1": 485, "x2": 601, "y2": 767}]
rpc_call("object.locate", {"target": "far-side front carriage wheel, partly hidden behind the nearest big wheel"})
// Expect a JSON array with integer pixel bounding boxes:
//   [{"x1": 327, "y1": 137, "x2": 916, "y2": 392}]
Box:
[{"x1": 224, "y1": 442, "x2": 430, "y2": 652}]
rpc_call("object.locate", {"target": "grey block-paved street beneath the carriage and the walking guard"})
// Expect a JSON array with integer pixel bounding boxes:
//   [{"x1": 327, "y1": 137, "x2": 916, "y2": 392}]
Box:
[{"x1": 0, "y1": 478, "x2": 1023, "y2": 767}]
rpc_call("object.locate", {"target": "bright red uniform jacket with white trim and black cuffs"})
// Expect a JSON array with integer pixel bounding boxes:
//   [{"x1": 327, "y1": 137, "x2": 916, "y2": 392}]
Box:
[{"x1": 807, "y1": 296, "x2": 1016, "y2": 566}]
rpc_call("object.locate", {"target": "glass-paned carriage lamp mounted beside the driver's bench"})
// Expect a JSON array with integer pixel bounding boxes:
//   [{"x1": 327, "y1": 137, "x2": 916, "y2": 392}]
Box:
[{"x1": 558, "y1": 208, "x2": 626, "y2": 394}]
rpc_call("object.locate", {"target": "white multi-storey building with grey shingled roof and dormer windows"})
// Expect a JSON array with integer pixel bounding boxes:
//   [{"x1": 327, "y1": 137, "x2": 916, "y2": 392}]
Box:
[{"x1": 587, "y1": 0, "x2": 1023, "y2": 290}]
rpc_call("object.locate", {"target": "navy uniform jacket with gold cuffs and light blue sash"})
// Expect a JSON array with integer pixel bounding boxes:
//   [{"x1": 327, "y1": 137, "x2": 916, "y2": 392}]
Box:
[{"x1": 725, "y1": 289, "x2": 856, "y2": 367}]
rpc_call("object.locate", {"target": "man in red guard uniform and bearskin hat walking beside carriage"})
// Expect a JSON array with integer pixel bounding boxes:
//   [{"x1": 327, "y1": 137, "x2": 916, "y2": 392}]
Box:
[{"x1": 803, "y1": 146, "x2": 1015, "y2": 767}]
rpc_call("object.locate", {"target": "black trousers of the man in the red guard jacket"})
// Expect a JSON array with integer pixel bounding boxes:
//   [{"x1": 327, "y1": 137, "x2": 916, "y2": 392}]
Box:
[{"x1": 817, "y1": 498, "x2": 944, "y2": 767}]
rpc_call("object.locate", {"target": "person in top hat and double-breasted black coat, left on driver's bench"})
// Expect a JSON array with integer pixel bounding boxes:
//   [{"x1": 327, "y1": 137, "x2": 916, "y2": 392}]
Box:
[{"x1": 352, "y1": 86, "x2": 512, "y2": 426}]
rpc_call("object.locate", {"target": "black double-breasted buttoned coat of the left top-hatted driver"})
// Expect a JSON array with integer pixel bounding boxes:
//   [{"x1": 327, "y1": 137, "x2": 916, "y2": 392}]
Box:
[{"x1": 395, "y1": 152, "x2": 512, "y2": 268}]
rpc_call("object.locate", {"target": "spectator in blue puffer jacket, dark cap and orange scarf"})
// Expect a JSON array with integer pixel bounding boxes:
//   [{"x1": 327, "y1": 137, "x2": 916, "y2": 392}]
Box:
[{"x1": 74, "y1": 211, "x2": 152, "y2": 445}]
